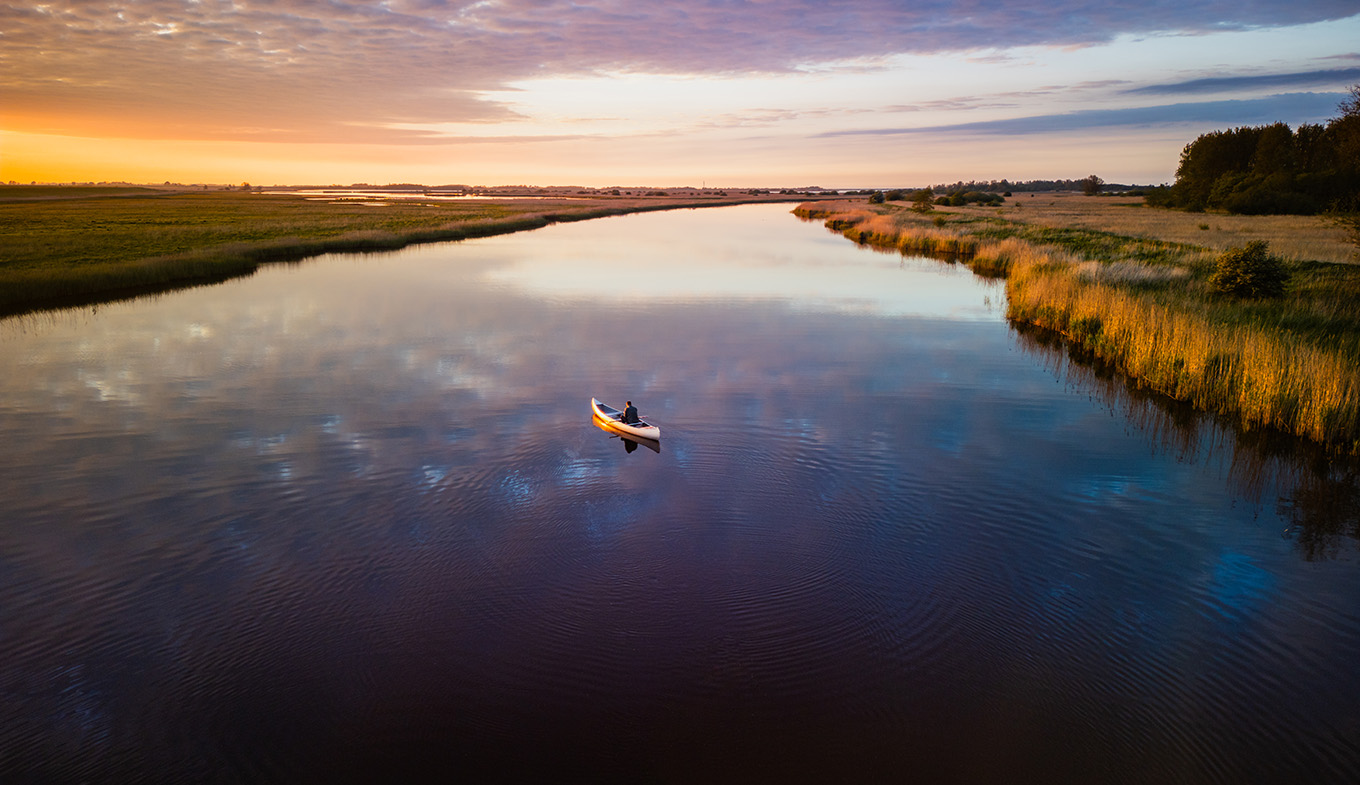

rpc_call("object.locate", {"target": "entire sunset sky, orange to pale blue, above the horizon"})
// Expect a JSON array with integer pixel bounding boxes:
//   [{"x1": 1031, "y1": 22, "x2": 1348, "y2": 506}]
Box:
[{"x1": 0, "y1": 0, "x2": 1360, "y2": 188}]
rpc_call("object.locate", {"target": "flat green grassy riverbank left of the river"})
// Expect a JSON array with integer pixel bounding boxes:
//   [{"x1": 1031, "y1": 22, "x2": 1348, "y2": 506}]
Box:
[{"x1": 0, "y1": 189, "x2": 826, "y2": 316}]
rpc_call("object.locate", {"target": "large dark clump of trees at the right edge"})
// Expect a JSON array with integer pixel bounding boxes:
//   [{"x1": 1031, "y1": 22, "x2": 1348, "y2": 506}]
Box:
[{"x1": 1146, "y1": 86, "x2": 1360, "y2": 215}]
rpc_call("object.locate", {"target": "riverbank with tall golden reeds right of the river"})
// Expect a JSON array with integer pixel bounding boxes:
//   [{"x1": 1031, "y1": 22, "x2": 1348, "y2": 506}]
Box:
[{"x1": 794, "y1": 200, "x2": 1360, "y2": 454}]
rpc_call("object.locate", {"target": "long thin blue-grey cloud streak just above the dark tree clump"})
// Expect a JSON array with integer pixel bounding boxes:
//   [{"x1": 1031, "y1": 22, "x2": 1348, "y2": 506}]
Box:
[{"x1": 817, "y1": 93, "x2": 1345, "y2": 137}]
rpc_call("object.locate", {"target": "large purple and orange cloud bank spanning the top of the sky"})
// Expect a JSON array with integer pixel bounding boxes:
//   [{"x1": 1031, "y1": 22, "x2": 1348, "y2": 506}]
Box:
[{"x1": 0, "y1": 0, "x2": 1356, "y2": 141}]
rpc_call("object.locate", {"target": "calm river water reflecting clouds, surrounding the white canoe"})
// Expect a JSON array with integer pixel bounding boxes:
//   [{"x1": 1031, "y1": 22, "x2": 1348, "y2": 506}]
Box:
[{"x1": 0, "y1": 205, "x2": 1360, "y2": 782}]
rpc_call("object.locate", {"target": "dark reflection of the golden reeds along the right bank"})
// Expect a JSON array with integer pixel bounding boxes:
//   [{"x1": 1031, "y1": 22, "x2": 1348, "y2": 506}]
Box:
[{"x1": 1012, "y1": 322, "x2": 1360, "y2": 561}]
